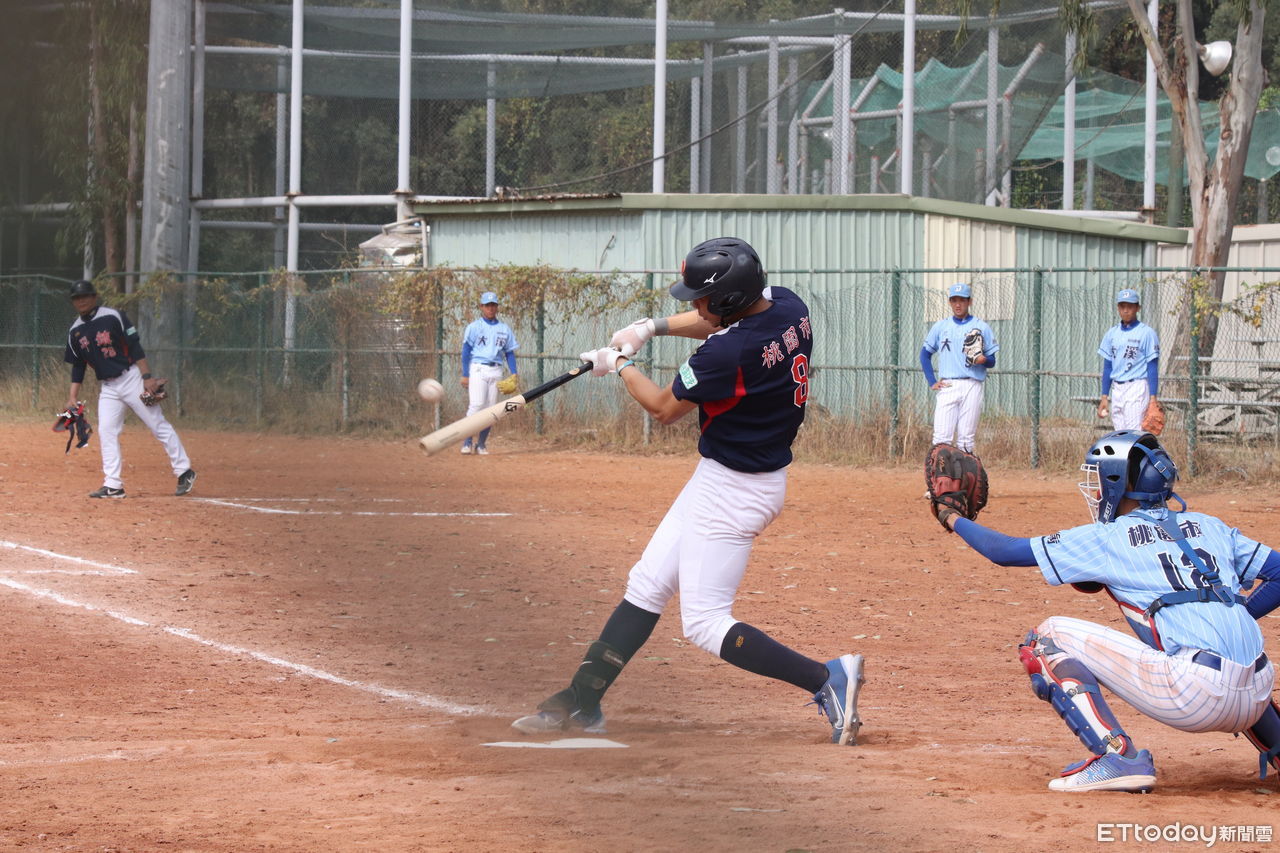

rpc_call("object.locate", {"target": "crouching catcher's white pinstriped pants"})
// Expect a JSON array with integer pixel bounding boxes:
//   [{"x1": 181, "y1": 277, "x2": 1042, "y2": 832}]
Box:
[{"x1": 1036, "y1": 616, "x2": 1275, "y2": 733}]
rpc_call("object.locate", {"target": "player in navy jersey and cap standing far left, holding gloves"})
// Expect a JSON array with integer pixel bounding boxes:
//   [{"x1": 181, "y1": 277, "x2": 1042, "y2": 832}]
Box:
[{"x1": 63, "y1": 280, "x2": 196, "y2": 498}]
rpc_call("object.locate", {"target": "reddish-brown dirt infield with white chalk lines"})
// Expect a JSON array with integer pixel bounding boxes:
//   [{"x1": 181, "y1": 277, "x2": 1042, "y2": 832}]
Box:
[{"x1": 0, "y1": 419, "x2": 1280, "y2": 853}]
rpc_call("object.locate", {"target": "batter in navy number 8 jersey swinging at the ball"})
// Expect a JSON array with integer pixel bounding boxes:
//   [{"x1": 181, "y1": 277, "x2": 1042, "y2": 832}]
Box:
[{"x1": 512, "y1": 237, "x2": 863, "y2": 744}]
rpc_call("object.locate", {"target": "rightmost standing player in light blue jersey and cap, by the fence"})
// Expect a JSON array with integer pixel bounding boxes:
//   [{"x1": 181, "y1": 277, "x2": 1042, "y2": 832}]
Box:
[{"x1": 1098, "y1": 288, "x2": 1160, "y2": 429}]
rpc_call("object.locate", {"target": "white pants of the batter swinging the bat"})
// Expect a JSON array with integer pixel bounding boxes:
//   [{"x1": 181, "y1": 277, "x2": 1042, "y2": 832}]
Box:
[{"x1": 625, "y1": 457, "x2": 787, "y2": 654}]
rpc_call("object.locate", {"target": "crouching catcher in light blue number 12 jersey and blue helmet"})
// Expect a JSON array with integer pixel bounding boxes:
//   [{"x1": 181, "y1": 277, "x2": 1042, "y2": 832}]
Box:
[{"x1": 940, "y1": 430, "x2": 1280, "y2": 792}]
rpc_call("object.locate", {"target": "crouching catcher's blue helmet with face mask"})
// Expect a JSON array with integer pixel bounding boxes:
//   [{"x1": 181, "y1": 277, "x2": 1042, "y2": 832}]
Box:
[{"x1": 1080, "y1": 429, "x2": 1187, "y2": 524}]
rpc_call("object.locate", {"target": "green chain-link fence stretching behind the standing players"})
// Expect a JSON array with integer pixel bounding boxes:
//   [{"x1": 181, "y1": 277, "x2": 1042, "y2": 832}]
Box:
[{"x1": 0, "y1": 266, "x2": 1280, "y2": 469}]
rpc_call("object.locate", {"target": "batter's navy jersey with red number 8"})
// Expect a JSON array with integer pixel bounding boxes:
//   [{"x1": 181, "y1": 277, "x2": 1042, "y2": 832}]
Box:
[{"x1": 671, "y1": 287, "x2": 813, "y2": 474}]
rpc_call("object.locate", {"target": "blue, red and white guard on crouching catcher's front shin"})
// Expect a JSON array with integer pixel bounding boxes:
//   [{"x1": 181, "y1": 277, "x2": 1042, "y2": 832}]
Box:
[{"x1": 1018, "y1": 631, "x2": 1137, "y2": 757}]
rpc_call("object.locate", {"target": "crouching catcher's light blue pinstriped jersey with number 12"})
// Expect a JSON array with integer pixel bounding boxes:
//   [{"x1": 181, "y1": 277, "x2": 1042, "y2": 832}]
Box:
[{"x1": 1030, "y1": 510, "x2": 1271, "y2": 665}]
